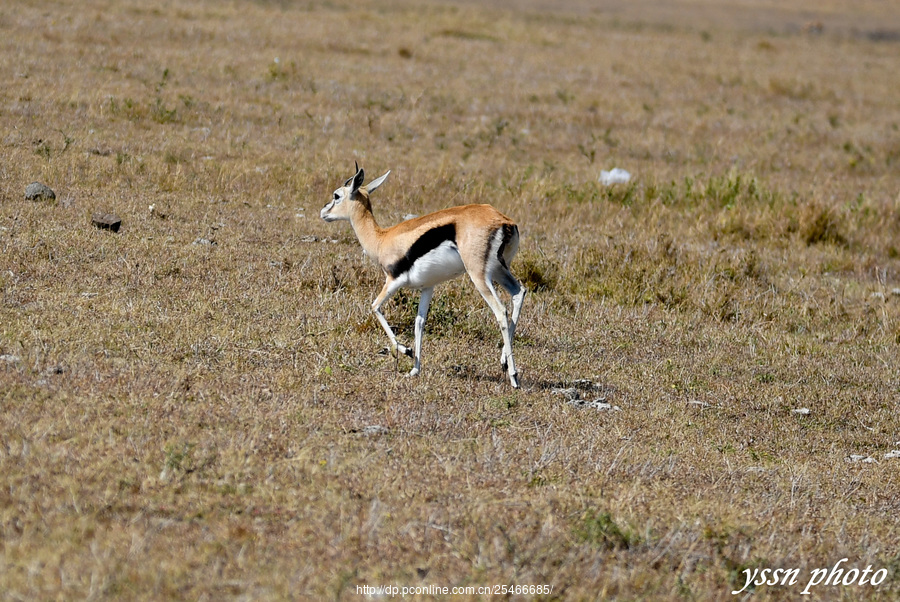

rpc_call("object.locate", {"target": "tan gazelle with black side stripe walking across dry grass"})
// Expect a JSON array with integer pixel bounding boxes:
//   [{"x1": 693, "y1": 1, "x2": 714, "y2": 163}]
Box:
[{"x1": 321, "y1": 165, "x2": 525, "y2": 388}]
